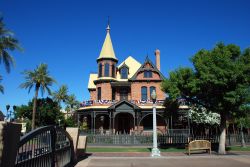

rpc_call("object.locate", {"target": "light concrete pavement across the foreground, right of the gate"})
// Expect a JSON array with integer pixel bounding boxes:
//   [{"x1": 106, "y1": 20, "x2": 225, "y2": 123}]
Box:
[{"x1": 75, "y1": 154, "x2": 250, "y2": 167}]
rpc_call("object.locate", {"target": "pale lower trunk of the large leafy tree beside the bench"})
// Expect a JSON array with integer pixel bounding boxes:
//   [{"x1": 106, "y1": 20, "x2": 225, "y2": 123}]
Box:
[{"x1": 218, "y1": 113, "x2": 227, "y2": 154}]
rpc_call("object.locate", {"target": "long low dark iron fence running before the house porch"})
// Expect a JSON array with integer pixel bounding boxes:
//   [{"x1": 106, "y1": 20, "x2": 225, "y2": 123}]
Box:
[{"x1": 85, "y1": 133, "x2": 250, "y2": 146}]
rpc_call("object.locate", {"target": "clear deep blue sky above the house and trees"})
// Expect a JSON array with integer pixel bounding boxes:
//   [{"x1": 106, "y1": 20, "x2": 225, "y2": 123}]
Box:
[{"x1": 0, "y1": 0, "x2": 250, "y2": 113}]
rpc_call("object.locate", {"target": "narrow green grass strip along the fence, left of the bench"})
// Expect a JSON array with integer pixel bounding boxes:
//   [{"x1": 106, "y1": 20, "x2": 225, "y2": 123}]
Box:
[{"x1": 87, "y1": 147, "x2": 185, "y2": 152}]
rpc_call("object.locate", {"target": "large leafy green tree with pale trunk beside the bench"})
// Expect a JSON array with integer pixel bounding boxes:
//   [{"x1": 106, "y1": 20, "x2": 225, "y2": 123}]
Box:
[{"x1": 162, "y1": 43, "x2": 250, "y2": 154}]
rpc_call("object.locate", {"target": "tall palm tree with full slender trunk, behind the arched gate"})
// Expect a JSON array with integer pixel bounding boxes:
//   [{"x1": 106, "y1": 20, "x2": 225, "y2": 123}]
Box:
[{"x1": 20, "y1": 64, "x2": 56, "y2": 130}]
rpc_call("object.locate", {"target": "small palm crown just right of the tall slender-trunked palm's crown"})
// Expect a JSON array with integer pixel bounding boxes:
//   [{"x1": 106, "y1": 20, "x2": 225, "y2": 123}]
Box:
[{"x1": 52, "y1": 85, "x2": 68, "y2": 105}]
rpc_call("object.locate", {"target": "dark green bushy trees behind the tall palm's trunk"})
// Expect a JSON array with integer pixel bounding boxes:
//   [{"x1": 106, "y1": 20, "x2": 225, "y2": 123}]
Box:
[{"x1": 15, "y1": 97, "x2": 65, "y2": 130}]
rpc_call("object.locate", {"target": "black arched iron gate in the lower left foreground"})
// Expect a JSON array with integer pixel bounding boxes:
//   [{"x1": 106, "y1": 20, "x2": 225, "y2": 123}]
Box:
[{"x1": 15, "y1": 126, "x2": 74, "y2": 167}]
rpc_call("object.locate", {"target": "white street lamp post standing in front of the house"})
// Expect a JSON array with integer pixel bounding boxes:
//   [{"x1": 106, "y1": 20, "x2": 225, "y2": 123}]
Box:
[{"x1": 151, "y1": 90, "x2": 161, "y2": 157}]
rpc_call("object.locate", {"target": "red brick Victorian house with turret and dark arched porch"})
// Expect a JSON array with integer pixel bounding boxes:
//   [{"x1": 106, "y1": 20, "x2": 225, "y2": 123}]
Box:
[{"x1": 78, "y1": 25, "x2": 167, "y2": 134}]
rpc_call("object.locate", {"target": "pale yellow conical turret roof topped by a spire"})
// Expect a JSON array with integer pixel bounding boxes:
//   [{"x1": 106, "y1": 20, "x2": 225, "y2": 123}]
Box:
[{"x1": 97, "y1": 25, "x2": 118, "y2": 61}]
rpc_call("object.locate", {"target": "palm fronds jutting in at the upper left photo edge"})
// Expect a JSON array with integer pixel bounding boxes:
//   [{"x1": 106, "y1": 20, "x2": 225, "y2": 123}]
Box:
[{"x1": 0, "y1": 18, "x2": 22, "y2": 72}]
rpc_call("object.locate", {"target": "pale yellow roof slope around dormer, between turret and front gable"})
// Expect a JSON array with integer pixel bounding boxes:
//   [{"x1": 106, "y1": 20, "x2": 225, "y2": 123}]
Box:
[{"x1": 116, "y1": 56, "x2": 141, "y2": 81}]
